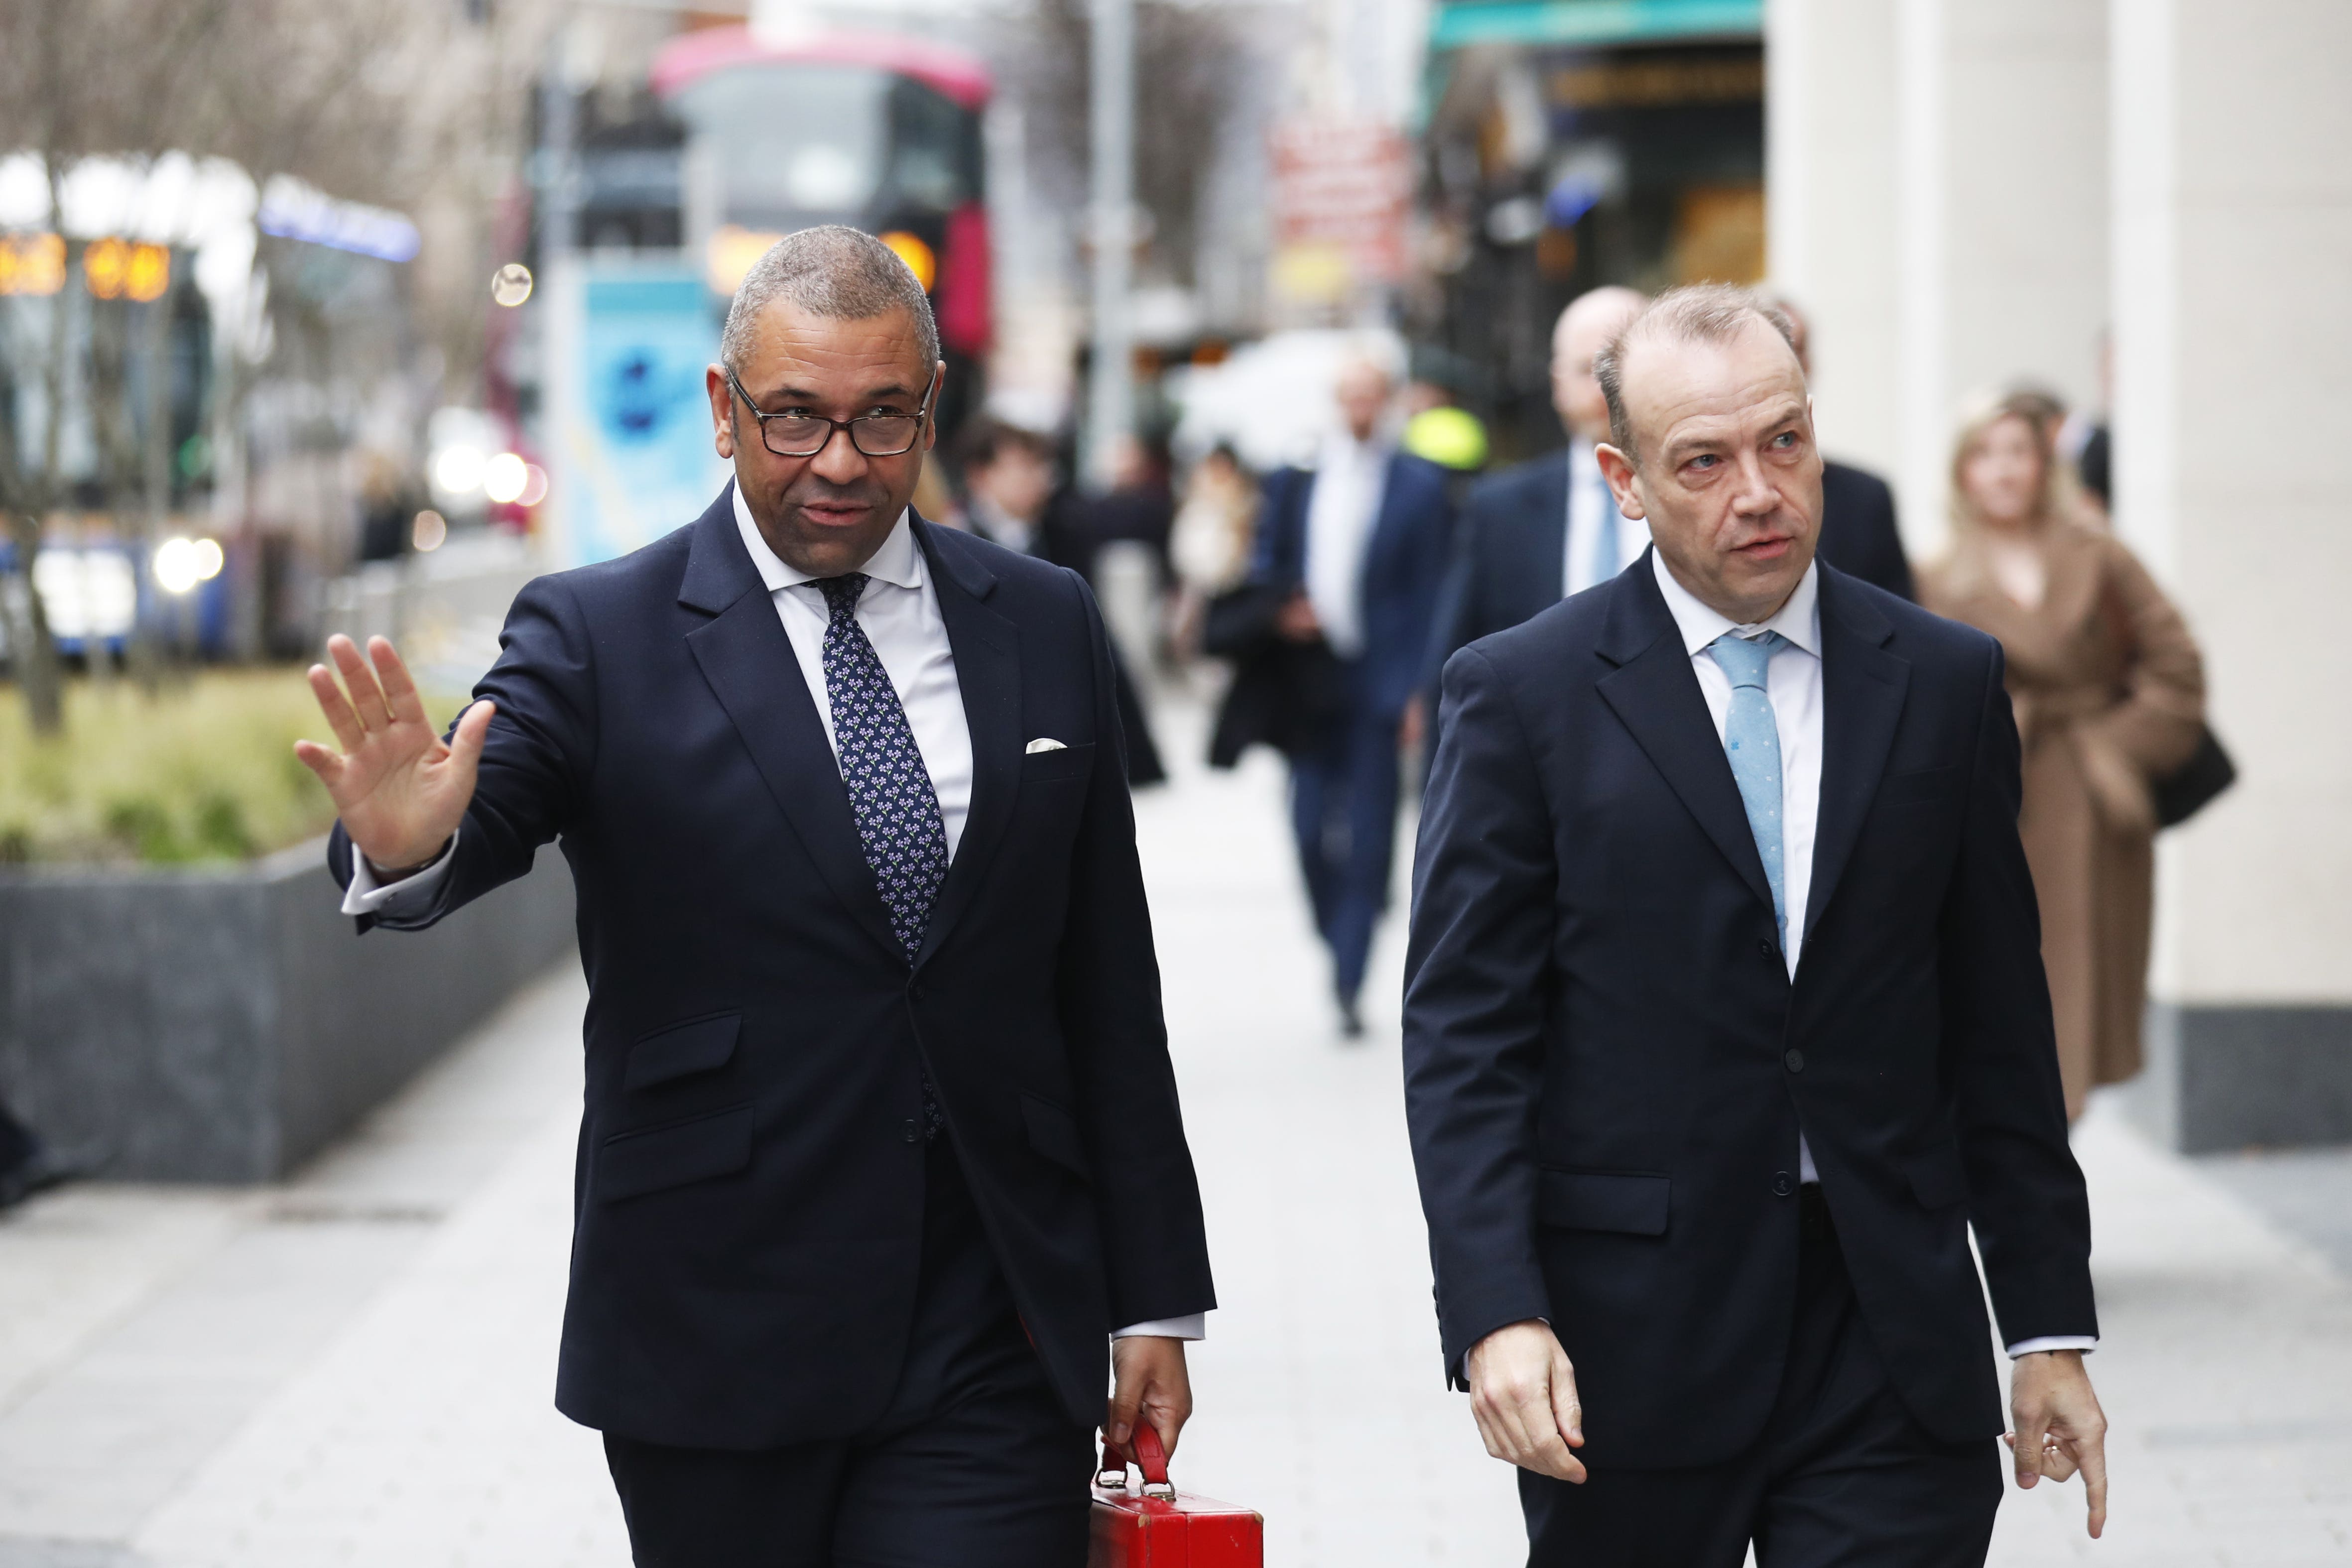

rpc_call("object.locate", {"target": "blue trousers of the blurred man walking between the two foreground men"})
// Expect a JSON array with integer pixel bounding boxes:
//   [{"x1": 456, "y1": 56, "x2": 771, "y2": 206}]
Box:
[{"x1": 1291, "y1": 705, "x2": 1397, "y2": 1001}]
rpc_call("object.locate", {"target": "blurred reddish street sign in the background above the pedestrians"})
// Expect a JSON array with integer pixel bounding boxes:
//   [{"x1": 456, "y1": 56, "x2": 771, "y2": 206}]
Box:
[{"x1": 1272, "y1": 120, "x2": 1414, "y2": 303}]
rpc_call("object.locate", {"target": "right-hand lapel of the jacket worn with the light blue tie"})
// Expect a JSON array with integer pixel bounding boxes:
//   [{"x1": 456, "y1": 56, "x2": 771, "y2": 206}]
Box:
[{"x1": 1804, "y1": 567, "x2": 1910, "y2": 936}]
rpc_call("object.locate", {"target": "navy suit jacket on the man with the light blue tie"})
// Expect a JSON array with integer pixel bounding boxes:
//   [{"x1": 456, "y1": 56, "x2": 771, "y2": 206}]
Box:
[{"x1": 1404, "y1": 555, "x2": 2098, "y2": 1469}]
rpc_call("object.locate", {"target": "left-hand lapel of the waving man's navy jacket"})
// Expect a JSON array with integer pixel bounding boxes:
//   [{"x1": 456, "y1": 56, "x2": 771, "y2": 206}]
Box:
[{"x1": 680, "y1": 491, "x2": 905, "y2": 959}]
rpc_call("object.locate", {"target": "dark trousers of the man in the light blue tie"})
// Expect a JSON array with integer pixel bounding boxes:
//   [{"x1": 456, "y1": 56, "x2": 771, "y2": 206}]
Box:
[{"x1": 1519, "y1": 1187, "x2": 2001, "y2": 1568}]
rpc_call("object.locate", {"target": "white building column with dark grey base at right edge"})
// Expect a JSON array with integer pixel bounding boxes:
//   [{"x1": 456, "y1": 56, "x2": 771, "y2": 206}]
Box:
[{"x1": 2112, "y1": 0, "x2": 2352, "y2": 1147}]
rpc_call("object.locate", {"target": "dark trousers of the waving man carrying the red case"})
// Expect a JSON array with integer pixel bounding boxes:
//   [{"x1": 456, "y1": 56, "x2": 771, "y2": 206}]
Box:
[{"x1": 605, "y1": 1133, "x2": 1094, "y2": 1568}]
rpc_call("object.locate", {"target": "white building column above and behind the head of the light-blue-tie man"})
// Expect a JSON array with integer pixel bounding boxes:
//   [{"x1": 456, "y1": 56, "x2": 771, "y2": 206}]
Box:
[{"x1": 1764, "y1": 0, "x2": 2107, "y2": 560}]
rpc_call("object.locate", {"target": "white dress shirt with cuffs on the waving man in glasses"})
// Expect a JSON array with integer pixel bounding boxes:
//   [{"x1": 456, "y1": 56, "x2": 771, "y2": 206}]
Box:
[{"x1": 344, "y1": 486, "x2": 1207, "y2": 1340}]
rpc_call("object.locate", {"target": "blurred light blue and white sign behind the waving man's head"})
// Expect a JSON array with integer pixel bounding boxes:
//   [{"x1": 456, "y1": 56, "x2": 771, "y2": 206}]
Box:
[{"x1": 553, "y1": 261, "x2": 729, "y2": 564}]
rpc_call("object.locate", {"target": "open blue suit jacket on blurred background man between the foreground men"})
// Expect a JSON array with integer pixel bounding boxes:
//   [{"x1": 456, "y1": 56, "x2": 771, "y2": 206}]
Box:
[{"x1": 1249, "y1": 451, "x2": 1454, "y2": 717}]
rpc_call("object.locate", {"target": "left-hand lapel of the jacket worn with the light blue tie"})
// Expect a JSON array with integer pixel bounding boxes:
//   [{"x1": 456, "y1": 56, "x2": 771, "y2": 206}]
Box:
[{"x1": 1597, "y1": 555, "x2": 1773, "y2": 910}]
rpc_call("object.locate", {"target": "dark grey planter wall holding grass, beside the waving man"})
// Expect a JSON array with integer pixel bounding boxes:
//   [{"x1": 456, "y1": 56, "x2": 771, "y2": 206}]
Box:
[{"x1": 0, "y1": 844, "x2": 572, "y2": 1183}]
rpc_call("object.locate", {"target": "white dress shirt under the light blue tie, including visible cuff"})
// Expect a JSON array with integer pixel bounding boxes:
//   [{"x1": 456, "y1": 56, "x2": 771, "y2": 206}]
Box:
[{"x1": 1649, "y1": 555, "x2": 2098, "y2": 1356}]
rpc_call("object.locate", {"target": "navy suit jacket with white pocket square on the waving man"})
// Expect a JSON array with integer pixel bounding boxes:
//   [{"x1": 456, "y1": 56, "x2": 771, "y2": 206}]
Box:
[{"x1": 329, "y1": 493, "x2": 1214, "y2": 1448}]
